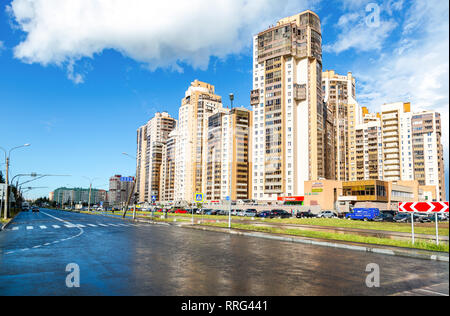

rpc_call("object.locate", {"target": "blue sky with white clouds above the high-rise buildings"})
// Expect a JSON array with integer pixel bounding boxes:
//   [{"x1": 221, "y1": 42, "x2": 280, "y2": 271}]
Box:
[{"x1": 0, "y1": 0, "x2": 449, "y2": 197}]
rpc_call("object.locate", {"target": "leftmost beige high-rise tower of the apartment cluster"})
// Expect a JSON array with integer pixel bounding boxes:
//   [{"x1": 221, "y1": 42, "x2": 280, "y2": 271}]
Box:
[{"x1": 136, "y1": 112, "x2": 176, "y2": 202}]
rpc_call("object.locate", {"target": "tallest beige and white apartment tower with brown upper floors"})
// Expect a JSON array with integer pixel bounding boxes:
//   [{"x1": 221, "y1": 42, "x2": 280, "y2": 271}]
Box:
[{"x1": 251, "y1": 11, "x2": 327, "y2": 200}]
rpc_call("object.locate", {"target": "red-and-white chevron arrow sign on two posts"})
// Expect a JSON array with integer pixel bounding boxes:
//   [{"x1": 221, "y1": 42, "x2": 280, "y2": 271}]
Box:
[{"x1": 398, "y1": 202, "x2": 449, "y2": 245}]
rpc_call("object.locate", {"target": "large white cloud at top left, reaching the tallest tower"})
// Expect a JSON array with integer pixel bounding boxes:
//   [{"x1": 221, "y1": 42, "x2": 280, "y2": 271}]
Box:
[{"x1": 7, "y1": 0, "x2": 316, "y2": 83}]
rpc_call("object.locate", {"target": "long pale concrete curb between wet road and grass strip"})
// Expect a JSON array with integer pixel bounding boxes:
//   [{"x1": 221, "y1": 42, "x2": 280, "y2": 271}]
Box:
[{"x1": 54, "y1": 211, "x2": 449, "y2": 262}]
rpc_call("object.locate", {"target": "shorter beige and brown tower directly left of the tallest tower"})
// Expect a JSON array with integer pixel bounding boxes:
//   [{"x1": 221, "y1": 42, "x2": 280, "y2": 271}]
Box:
[{"x1": 203, "y1": 108, "x2": 252, "y2": 201}]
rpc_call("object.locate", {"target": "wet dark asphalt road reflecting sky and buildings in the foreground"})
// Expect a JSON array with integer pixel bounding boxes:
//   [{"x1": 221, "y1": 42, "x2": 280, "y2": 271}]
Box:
[{"x1": 0, "y1": 209, "x2": 449, "y2": 296}]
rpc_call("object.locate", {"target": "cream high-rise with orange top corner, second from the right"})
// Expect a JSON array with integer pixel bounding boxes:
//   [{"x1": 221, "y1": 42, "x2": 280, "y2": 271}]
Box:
[{"x1": 381, "y1": 102, "x2": 414, "y2": 181}]
